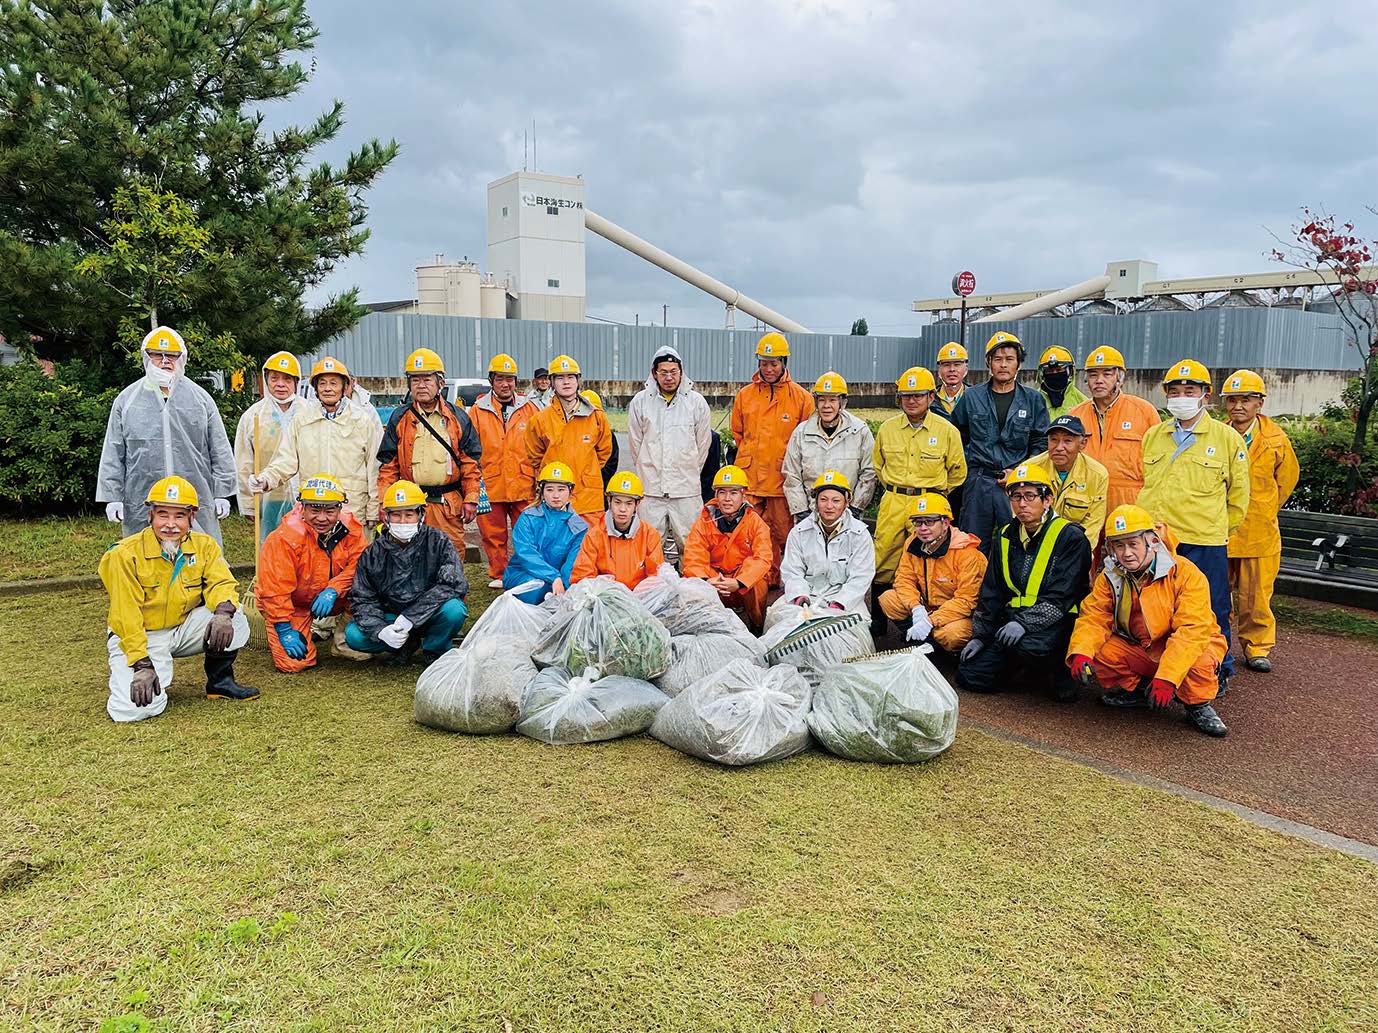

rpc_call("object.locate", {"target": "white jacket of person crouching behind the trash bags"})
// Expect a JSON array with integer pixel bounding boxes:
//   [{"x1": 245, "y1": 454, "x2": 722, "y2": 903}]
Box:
[{"x1": 780, "y1": 510, "x2": 875, "y2": 613}]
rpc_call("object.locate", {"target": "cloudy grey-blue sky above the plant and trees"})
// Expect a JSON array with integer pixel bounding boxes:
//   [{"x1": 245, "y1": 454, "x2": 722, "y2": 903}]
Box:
[{"x1": 271, "y1": 0, "x2": 1378, "y2": 333}]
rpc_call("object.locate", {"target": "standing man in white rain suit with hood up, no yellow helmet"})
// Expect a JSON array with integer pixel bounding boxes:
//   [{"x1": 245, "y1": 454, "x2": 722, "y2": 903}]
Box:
[{"x1": 627, "y1": 346, "x2": 714, "y2": 562}]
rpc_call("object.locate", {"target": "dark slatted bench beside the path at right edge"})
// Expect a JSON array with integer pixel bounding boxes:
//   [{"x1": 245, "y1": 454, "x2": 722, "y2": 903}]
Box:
[{"x1": 1277, "y1": 510, "x2": 1378, "y2": 610}]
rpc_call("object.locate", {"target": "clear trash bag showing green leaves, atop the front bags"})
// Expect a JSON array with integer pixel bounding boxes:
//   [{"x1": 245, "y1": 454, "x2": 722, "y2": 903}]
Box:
[{"x1": 531, "y1": 574, "x2": 670, "y2": 682}]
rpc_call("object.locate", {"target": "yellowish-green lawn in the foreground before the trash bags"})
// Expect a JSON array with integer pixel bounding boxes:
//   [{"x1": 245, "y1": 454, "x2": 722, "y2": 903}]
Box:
[{"x1": 0, "y1": 570, "x2": 1378, "y2": 1030}]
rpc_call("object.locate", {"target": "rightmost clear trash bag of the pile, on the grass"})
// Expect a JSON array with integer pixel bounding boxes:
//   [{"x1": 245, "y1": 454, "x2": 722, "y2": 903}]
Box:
[{"x1": 809, "y1": 649, "x2": 958, "y2": 764}]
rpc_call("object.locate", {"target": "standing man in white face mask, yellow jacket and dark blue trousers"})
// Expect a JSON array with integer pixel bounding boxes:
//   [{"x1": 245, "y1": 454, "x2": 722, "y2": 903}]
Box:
[{"x1": 1138, "y1": 358, "x2": 1248, "y2": 689}]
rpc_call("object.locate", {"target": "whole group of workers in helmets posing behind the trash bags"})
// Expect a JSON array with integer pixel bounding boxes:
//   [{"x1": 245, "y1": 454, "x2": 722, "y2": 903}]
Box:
[{"x1": 96, "y1": 328, "x2": 1298, "y2": 735}]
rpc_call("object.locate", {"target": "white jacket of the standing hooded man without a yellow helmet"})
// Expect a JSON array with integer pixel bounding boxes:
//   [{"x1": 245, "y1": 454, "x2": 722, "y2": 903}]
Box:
[{"x1": 627, "y1": 348, "x2": 714, "y2": 499}]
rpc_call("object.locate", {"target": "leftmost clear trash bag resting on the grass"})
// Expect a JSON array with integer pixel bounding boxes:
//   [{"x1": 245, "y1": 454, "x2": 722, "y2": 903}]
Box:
[{"x1": 412, "y1": 630, "x2": 536, "y2": 735}]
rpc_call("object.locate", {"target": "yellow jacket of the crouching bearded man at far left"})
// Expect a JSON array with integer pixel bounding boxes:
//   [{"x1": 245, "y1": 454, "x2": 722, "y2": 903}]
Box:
[{"x1": 101, "y1": 528, "x2": 240, "y2": 667}]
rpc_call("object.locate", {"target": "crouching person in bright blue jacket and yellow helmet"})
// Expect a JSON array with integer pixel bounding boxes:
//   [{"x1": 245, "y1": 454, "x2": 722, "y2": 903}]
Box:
[{"x1": 503, "y1": 463, "x2": 588, "y2": 603}]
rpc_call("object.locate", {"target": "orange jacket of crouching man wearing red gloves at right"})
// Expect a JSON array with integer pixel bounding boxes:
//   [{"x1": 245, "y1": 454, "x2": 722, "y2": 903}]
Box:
[{"x1": 1067, "y1": 526, "x2": 1226, "y2": 686}]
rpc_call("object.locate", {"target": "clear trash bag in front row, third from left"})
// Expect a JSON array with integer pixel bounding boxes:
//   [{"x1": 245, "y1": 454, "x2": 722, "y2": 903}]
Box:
[{"x1": 650, "y1": 660, "x2": 812, "y2": 766}]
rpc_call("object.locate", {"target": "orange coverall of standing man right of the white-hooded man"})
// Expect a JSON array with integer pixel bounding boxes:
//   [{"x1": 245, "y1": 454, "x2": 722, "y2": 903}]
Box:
[{"x1": 732, "y1": 369, "x2": 813, "y2": 588}]
